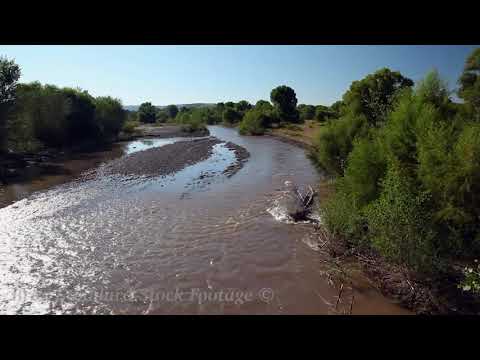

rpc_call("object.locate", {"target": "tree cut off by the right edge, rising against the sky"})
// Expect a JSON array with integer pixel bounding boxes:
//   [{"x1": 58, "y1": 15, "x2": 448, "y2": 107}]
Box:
[{"x1": 458, "y1": 48, "x2": 480, "y2": 121}]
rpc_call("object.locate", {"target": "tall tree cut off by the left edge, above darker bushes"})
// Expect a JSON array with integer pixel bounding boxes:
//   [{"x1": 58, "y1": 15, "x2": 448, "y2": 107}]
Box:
[{"x1": 0, "y1": 57, "x2": 21, "y2": 152}]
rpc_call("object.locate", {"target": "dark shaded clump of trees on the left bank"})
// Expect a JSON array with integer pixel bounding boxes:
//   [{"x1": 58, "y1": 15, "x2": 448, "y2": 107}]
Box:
[{"x1": 0, "y1": 59, "x2": 126, "y2": 152}]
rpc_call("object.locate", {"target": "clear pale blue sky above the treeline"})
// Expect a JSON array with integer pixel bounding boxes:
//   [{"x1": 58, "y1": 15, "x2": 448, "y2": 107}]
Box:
[{"x1": 0, "y1": 45, "x2": 477, "y2": 105}]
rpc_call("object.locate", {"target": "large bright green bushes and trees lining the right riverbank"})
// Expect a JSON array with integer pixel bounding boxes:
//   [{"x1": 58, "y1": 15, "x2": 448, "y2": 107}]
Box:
[{"x1": 313, "y1": 51, "x2": 480, "y2": 273}]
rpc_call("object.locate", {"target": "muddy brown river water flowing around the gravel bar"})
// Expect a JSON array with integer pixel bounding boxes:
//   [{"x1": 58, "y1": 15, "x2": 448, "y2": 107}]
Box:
[{"x1": 0, "y1": 126, "x2": 408, "y2": 314}]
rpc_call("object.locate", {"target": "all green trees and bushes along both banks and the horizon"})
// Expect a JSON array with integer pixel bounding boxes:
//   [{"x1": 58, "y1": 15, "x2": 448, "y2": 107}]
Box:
[{"x1": 0, "y1": 49, "x2": 480, "y2": 312}]
